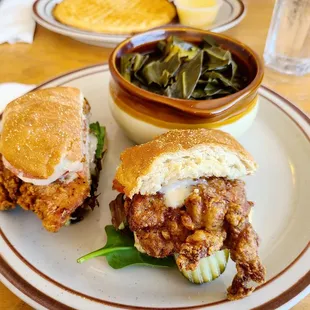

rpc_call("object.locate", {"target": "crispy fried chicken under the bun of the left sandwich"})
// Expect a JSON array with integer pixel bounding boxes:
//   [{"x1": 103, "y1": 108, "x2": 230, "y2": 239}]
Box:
[{"x1": 17, "y1": 177, "x2": 90, "y2": 232}]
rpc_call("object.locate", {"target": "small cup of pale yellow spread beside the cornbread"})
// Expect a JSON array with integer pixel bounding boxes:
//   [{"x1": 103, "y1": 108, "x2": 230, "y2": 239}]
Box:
[{"x1": 174, "y1": 0, "x2": 222, "y2": 29}]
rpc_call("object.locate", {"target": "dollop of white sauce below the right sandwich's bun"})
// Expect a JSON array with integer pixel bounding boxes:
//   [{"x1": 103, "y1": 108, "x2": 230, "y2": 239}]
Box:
[{"x1": 160, "y1": 179, "x2": 207, "y2": 208}]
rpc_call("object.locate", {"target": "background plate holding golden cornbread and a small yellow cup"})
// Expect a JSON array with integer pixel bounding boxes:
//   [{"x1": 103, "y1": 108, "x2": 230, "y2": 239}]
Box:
[{"x1": 33, "y1": 0, "x2": 246, "y2": 47}]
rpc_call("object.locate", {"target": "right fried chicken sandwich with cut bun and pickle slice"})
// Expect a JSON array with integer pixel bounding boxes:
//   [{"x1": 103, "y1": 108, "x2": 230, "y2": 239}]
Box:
[{"x1": 110, "y1": 129, "x2": 265, "y2": 300}]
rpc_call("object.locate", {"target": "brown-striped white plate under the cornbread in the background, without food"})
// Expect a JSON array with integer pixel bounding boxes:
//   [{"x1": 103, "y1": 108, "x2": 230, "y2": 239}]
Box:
[{"x1": 32, "y1": 0, "x2": 246, "y2": 47}]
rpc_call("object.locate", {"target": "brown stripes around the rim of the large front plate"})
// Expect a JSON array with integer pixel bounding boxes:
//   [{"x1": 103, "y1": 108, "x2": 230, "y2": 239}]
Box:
[{"x1": 0, "y1": 62, "x2": 310, "y2": 310}]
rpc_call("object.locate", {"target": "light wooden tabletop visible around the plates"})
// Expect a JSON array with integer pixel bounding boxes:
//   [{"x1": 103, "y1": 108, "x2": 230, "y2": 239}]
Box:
[{"x1": 0, "y1": 0, "x2": 310, "y2": 310}]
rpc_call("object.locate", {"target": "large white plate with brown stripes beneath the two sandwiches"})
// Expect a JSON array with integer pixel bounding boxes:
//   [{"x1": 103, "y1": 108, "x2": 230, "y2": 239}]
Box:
[{"x1": 0, "y1": 65, "x2": 310, "y2": 310}]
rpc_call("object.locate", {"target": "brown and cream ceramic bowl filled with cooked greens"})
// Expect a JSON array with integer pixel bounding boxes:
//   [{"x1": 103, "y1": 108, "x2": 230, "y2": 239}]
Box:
[{"x1": 109, "y1": 26, "x2": 264, "y2": 143}]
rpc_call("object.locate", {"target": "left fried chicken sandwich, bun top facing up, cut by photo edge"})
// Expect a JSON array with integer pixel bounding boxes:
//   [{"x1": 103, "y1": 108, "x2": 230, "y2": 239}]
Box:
[{"x1": 0, "y1": 87, "x2": 105, "y2": 232}]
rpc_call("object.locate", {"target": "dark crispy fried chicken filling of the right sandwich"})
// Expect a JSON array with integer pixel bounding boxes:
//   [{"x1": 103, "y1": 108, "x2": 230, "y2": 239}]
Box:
[{"x1": 112, "y1": 177, "x2": 266, "y2": 300}]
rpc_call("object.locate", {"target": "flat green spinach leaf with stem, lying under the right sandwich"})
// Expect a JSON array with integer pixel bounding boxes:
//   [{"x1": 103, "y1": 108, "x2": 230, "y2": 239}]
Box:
[{"x1": 77, "y1": 225, "x2": 175, "y2": 269}]
